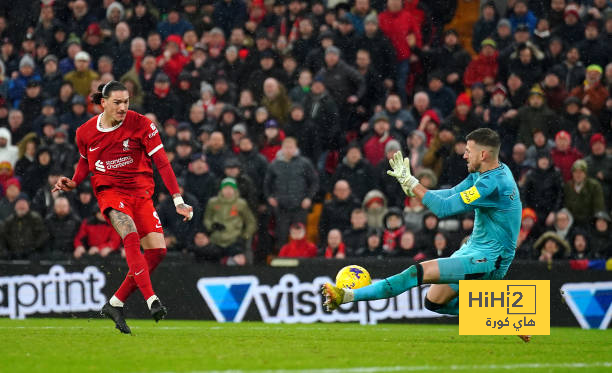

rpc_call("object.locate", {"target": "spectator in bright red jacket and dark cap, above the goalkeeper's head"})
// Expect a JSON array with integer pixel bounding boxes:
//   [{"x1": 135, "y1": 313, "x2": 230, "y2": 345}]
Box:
[{"x1": 463, "y1": 39, "x2": 499, "y2": 87}]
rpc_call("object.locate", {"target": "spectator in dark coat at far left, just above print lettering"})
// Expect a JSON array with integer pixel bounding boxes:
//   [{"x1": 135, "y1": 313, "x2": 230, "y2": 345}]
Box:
[{"x1": 0, "y1": 195, "x2": 49, "y2": 260}]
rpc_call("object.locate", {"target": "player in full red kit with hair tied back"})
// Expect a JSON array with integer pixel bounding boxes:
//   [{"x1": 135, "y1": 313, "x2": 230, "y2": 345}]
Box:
[{"x1": 54, "y1": 81, "x2": 193, "y2": 334}]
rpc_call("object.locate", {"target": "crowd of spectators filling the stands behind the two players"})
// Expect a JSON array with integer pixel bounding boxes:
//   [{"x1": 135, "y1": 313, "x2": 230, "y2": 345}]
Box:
[{"x1": 0, "y1": 0, "x2": 612, "y2": 265}]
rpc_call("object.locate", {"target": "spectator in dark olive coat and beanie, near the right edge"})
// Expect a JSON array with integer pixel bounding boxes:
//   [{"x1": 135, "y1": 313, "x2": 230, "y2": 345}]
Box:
[{"x1": 563, "y1": 159, "x2": 606, "y2": 228}]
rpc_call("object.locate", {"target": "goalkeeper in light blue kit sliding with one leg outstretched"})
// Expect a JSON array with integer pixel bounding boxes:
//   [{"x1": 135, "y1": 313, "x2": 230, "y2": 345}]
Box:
[{"x1": 321, "y1": 128, "x2": 529, "y2": 341}]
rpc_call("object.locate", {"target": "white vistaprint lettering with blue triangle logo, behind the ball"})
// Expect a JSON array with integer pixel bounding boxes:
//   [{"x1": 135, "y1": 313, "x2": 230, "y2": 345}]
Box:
[{"x1": 197, "y1": 274, "x2": 440, "y2": 324}]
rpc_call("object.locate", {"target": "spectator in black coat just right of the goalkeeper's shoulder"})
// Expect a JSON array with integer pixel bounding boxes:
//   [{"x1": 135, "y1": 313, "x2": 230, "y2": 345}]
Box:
[{"x1": 521, "y1": 151, "x2": 563, "y2": 227}]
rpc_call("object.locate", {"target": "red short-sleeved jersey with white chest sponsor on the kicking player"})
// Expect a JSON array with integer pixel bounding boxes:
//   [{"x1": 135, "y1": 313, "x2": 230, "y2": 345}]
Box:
[{"x1": 76, "y1": 110, "x2": 163, "y2": 196}]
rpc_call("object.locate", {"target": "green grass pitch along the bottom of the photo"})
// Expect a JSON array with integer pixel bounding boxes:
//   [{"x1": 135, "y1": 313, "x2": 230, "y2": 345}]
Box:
[{"x1": 0, "y1": 319, "x2": 612, "y2": 373}]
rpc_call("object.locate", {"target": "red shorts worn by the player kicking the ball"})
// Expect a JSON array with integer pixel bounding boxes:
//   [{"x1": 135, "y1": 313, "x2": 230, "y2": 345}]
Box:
[{"x1": 96, "y1": 189, "x2": 164, "y2": 237}]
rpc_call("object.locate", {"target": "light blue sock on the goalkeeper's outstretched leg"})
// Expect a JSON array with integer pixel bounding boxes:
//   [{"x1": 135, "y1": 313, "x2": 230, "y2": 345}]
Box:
[{"x1": 352, "y1": 264, "x2": 423, "y2": 303}]
